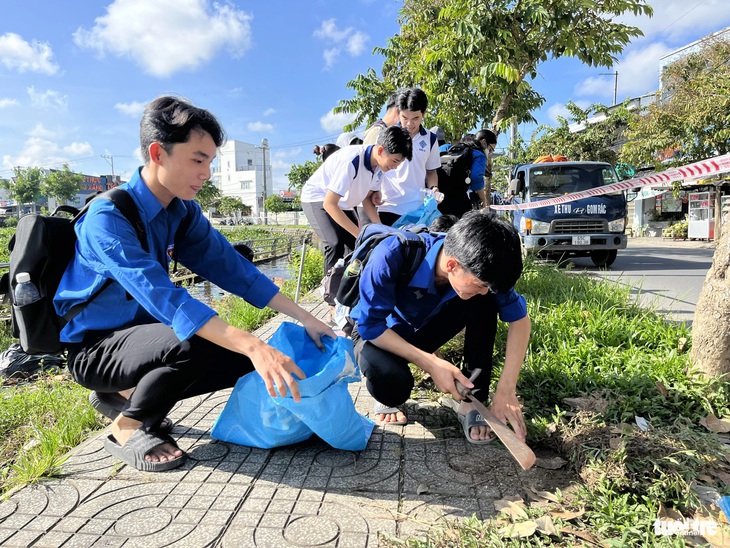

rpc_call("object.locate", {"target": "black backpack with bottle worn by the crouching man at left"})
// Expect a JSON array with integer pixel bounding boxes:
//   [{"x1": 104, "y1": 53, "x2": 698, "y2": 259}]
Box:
[{"x1": 0, "y1": 188, "x2": 149, "y2": 354}]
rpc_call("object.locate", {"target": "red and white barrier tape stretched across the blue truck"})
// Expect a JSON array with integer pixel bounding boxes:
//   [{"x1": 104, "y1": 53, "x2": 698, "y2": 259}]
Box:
[{"x1": 490, "y1": 154, "x2": 730, "y2": 211}]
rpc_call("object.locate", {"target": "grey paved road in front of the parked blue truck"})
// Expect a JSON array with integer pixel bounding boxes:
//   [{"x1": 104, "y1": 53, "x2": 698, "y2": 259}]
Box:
[{"x1": 574, "y1": 238, "x2": 715, "y2": 324}]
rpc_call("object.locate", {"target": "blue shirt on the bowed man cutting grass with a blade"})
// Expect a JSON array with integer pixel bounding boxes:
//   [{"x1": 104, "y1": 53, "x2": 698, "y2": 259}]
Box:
[{"x1": 350, "y1": 234, "x2": 527, "y2": 340}]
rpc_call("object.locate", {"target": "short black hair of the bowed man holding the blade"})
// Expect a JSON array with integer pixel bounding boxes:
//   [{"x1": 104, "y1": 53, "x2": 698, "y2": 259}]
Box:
[{"x1": 443, "y1": 211, "x2": 522, "y2": 292}]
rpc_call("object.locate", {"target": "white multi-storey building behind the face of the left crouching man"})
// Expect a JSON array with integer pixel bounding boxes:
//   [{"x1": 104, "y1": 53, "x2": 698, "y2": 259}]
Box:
[{"x1": 218, "y1": 139, "x2": 273, "y2": 219}]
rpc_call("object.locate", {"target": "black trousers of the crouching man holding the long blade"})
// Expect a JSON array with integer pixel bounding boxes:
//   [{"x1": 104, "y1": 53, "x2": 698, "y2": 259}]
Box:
[{"x1": 354, "y1": 294, "x2": 498, "y2": 407}]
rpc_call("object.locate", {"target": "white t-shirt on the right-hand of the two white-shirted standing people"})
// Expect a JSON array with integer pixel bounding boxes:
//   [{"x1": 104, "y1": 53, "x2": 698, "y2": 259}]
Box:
[{"x1": 378, "y1": 126, "x2": 441, "y2": 215}]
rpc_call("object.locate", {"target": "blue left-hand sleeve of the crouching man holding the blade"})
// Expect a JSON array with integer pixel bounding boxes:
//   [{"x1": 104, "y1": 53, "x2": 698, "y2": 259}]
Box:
[{"x1": 350, "y1": 238, "x2": 404, "y2": 341}]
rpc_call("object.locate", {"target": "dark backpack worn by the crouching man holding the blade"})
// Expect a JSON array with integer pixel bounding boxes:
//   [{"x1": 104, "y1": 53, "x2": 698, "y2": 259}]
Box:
[{"x1": 337, "y1": 223, "x2": 426, "y2": 309}]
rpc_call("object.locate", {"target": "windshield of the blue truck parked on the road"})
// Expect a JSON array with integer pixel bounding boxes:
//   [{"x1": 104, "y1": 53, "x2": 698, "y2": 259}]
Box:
[{"x1": 530, "y1": 165, "x2": 617, "y2": 197}]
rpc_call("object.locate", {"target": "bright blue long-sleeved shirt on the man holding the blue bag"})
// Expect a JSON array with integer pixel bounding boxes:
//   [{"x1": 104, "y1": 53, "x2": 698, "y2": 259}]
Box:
[{"x1": 54, "y1": 170, "x2": 278, "y2": 342}]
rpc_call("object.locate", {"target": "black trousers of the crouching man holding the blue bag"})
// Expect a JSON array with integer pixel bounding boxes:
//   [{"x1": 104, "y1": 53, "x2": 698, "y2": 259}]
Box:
[{"x1": 68, "y1": 323, "x2": 254, "y2": 428}]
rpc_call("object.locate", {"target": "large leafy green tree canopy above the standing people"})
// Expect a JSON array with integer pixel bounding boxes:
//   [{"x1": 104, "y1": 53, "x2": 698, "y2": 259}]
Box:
[{"x1": 335, "y1": 0, "x2": 653, "y2": 138}]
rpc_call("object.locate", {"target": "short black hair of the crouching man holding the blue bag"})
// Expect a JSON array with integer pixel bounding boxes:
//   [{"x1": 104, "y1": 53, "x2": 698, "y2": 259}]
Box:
[{"x1": 139, "y1": 95, "x2": 226, "y2": 164}]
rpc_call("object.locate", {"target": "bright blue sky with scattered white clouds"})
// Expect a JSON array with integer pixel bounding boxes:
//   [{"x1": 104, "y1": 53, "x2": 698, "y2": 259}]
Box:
[{"x1": 0, "y1": 0, "x2": 730, "y2": 193}]
